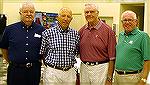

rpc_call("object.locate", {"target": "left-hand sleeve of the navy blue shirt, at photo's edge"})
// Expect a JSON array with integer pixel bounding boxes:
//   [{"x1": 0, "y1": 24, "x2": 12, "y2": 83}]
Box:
[{"x1": 0, "y1": 28, "x2": 9, "y2": 49}]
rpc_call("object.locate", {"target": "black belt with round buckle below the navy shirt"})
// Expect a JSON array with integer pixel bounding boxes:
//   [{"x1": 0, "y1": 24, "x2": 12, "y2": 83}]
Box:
[{"x1": 9, "y1": 62, "x2": 41, "y2": 68}]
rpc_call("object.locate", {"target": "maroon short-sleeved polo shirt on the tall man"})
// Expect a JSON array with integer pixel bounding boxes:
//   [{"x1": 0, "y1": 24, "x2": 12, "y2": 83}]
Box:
[{"x1": 79, "y1": 21, "x2": 116, "y2": 62}]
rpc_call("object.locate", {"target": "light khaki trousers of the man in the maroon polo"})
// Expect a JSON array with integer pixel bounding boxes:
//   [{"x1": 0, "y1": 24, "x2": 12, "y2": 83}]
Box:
[{"x1": 80, "y1": 62, "x2": 108, "y2": 85}]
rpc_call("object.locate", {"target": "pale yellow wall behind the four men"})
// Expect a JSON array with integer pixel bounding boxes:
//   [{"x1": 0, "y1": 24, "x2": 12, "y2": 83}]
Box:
[{"x1": 3, "y1": 0, "x2": 120, "y2": 30}]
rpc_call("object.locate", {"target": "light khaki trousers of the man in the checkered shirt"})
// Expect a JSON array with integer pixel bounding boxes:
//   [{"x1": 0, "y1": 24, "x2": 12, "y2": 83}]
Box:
[{"x1": 43, "y1": 66, "x2": 76, "y2": 85}]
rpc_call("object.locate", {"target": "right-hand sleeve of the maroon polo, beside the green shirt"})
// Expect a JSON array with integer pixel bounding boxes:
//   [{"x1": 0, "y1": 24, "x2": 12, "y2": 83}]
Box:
[{"x1": 108, "y1": 30, "x2": 116, "y2": 60}]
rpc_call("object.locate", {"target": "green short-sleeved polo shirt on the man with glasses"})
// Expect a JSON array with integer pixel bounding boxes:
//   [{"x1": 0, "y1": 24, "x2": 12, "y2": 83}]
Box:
[{"x1": 115, "y1": 28, "x2": 150, "y2": 71}]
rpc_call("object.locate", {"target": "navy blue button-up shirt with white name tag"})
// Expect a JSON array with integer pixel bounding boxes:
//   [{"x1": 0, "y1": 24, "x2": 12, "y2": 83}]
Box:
[{"x1": 0, "y1": 22, "x2": 45, "y2": 63}]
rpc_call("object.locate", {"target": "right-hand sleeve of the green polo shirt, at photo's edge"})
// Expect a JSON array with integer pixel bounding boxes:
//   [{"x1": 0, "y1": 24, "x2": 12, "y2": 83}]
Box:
[{"x1": 142, "y1": 33, "x2": 150, "y2": 60}]
